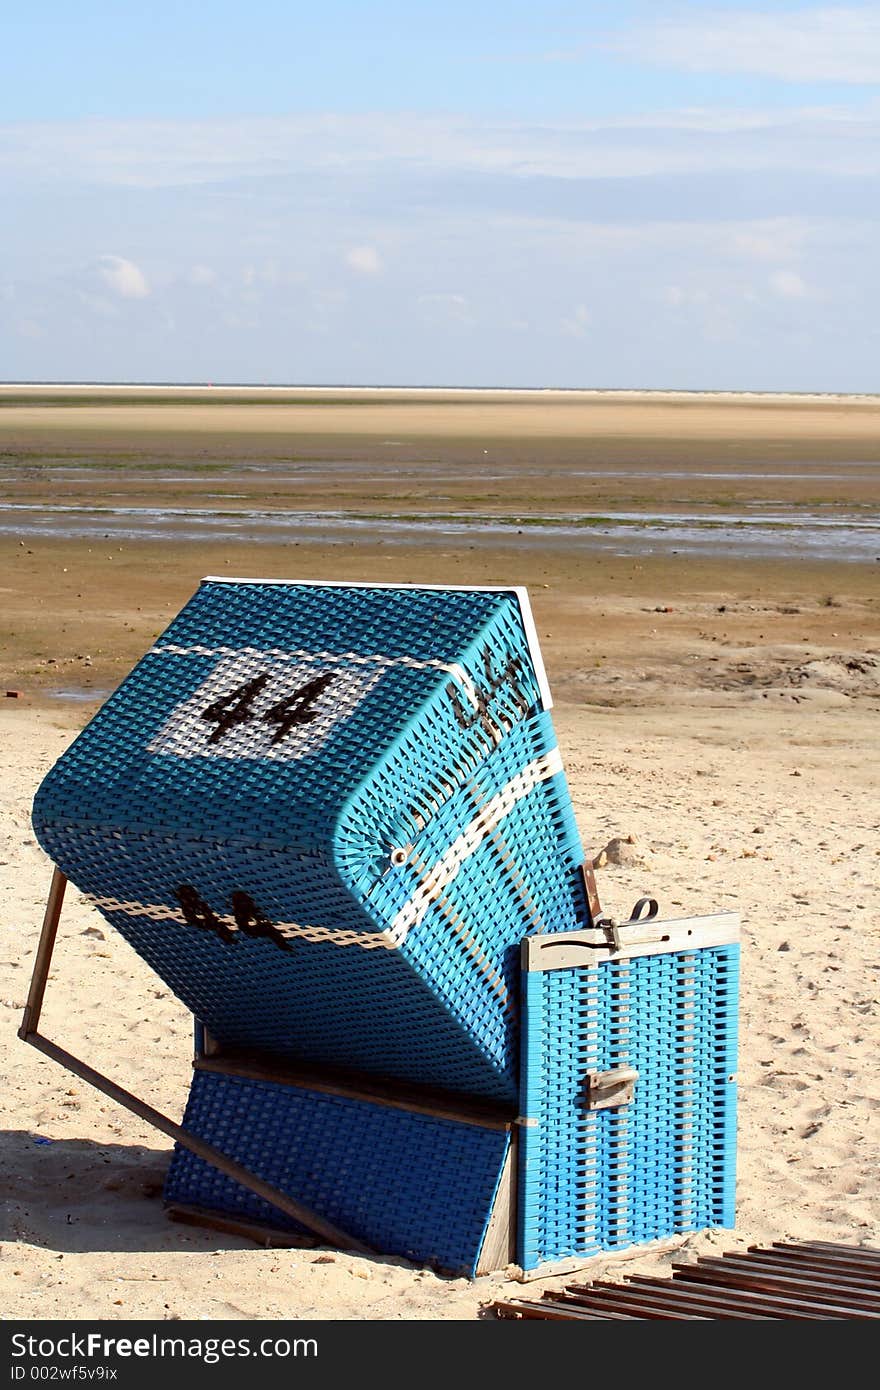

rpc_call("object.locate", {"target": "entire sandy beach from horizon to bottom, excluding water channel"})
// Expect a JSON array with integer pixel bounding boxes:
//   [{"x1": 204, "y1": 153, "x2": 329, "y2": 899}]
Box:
[{"x1": 0, "y1": 388, "x2": 880, "y2": 1319}]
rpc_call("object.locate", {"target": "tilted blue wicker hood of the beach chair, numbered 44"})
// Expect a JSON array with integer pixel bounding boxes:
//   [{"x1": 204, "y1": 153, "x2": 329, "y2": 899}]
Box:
[{"x1": 33, "y1": 582, "x2": 584, "y2": 1102}]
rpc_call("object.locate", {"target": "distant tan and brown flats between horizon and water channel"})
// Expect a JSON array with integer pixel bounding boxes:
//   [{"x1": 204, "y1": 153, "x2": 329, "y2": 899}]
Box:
[{"x1": 0, "y1": 386, "x2": 880, "y2": 506}]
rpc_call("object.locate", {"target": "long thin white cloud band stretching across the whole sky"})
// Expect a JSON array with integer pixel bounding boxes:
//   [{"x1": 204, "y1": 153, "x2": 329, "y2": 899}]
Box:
[{"x1": 0, "y1": 102, "x2": 880, "y2": 196}]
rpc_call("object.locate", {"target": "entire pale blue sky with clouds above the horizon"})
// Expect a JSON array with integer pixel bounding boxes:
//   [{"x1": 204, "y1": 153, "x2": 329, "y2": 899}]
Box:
[{"x1": 0, "y1": 0, "x2": 880, "y2": 392}]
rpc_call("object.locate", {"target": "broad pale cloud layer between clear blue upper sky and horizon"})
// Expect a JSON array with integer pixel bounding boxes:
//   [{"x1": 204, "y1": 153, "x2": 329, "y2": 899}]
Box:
[{"x1": 0, "y1": 93, "x2": 880, "y2": 389}]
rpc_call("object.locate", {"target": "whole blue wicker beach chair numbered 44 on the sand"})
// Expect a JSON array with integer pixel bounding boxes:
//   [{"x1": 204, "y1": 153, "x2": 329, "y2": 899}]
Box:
[{"x1": 21, "y1": 580, "x2": 738, "y2": 1275}]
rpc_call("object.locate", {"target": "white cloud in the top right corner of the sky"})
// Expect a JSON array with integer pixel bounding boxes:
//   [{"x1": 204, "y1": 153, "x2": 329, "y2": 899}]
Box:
[{"x1": 606, "y1": 4, "x2": 880, "y2": 85}]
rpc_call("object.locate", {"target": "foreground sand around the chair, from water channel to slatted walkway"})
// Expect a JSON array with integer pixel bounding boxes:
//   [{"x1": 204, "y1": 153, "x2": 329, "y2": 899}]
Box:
[{"x1": 0, "y1": 386, "x2": 880, "y2": 1319}]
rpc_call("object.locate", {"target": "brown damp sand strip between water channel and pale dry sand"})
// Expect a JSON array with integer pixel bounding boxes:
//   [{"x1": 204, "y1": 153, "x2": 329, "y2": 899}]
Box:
[{"x1": 0, "y1": 535, "x2": 880, "y2": 702}]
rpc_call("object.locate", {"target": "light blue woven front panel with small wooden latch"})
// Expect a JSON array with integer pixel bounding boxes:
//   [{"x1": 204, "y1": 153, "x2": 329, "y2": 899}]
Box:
[{"x1": 519, "y1": 945, "x2": 740, "y2": 1269}]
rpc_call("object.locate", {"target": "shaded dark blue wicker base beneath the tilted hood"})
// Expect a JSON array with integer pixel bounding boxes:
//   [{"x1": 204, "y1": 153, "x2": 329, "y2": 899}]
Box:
[{"x1": 164, "y1": 1072, "x2": 510, "y2": 1275}]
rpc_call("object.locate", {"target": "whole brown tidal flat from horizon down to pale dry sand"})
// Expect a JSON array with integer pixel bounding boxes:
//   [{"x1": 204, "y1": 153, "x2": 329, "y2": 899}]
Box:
[{"x1": 0, "y1": 386, "x2": 880, "y2": 696}]
